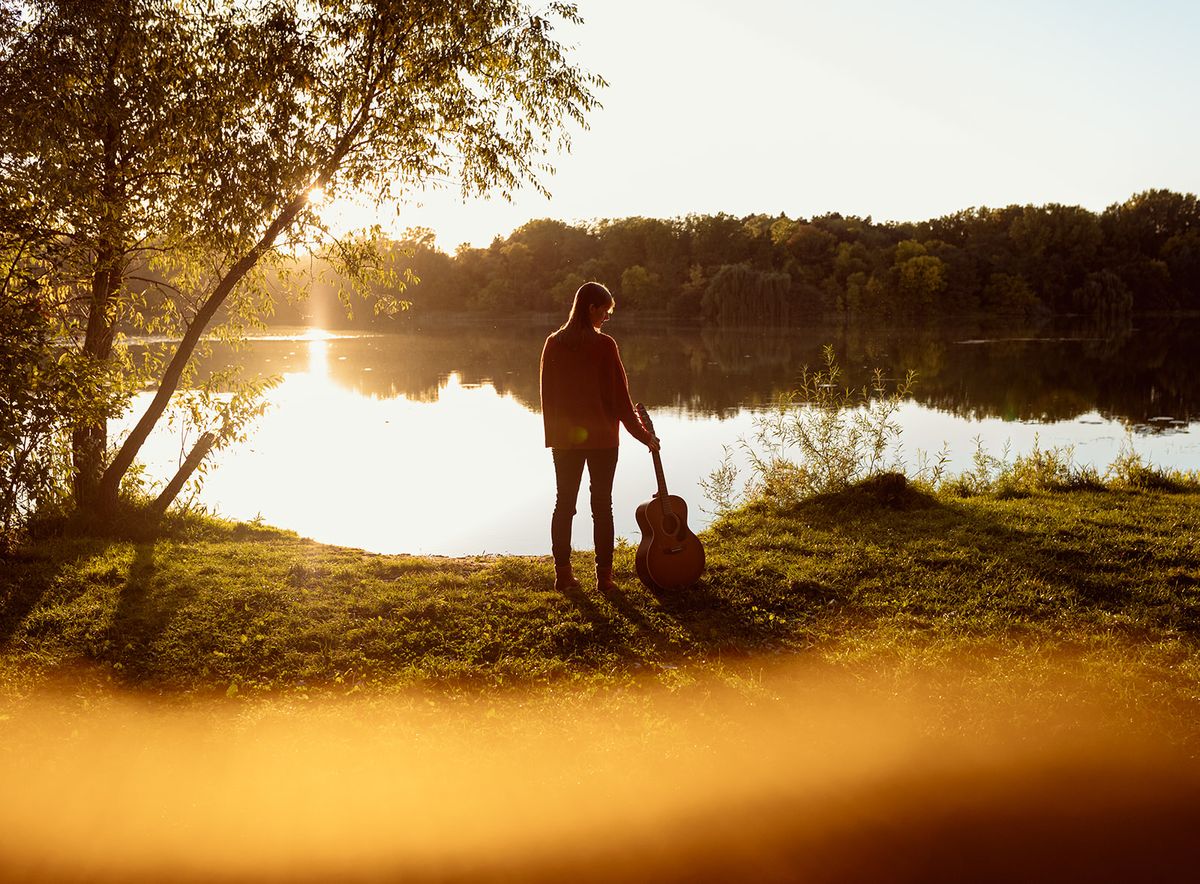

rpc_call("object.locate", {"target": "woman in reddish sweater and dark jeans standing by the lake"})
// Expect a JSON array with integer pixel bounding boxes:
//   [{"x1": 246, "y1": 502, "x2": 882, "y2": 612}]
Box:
[{"x1": 541, "y1": 282, "x2": 659, "y2": 590}]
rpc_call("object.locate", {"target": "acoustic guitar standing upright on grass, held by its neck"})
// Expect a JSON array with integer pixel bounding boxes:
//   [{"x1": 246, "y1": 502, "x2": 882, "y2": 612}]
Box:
[{"x1": 634, "y1": 402, "x2": 704, "y2": 589}]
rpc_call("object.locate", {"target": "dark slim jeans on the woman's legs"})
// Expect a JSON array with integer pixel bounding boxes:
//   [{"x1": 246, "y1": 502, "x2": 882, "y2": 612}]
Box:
[{"x1": 550, "y1": 449, "x2": 617, "y2": 567}]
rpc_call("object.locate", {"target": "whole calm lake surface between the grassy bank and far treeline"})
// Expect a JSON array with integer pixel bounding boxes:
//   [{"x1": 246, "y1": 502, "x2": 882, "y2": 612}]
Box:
[{"x1": 124, "y1": 317, "x2": 1200, "y2": 555}]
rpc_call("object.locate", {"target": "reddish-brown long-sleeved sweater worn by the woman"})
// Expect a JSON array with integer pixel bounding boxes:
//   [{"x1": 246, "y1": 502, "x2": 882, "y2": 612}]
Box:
[{"x1": 541, "y1": 332, "x2": 650, "y2": 449}]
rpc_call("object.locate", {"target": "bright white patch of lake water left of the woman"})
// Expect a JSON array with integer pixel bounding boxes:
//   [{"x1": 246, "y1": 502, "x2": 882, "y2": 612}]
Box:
[{"x1": 204, "y1": 364, "x2": 545, "y2": 554}]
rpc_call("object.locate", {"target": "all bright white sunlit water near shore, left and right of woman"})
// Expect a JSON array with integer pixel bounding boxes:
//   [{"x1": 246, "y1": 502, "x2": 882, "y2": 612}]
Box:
[{"x1": 117, "y1": 329, "x2": 1200, "y2": 555}]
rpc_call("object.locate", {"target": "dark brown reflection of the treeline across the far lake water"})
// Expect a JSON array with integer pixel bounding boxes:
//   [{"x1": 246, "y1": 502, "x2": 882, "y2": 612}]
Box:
[{"x1": 192, "y1": 319, "x2": 1200, "y2": 426}]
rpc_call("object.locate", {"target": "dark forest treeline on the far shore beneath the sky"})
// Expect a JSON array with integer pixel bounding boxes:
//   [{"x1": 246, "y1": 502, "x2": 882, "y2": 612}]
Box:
[{"x1": 277, "y1": 190, "x2": 1200, "y2": 325}]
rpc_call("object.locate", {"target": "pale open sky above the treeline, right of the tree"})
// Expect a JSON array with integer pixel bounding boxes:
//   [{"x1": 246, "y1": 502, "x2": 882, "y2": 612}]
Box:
[{"x1": 328, "y1": 0, "x2": 1200, "y2": 252}]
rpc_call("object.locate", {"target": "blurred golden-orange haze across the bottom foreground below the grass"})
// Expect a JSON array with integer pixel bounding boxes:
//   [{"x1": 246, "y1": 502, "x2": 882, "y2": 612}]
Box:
[{"x1": 0, "y1": 664, "x2": 1200, "y2": 882}]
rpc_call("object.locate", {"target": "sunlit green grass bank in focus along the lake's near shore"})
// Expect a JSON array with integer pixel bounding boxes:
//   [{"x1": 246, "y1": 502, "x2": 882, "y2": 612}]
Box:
[{"x1": 0, "y1": 477, "x2": 1200, "y2": 741}]
